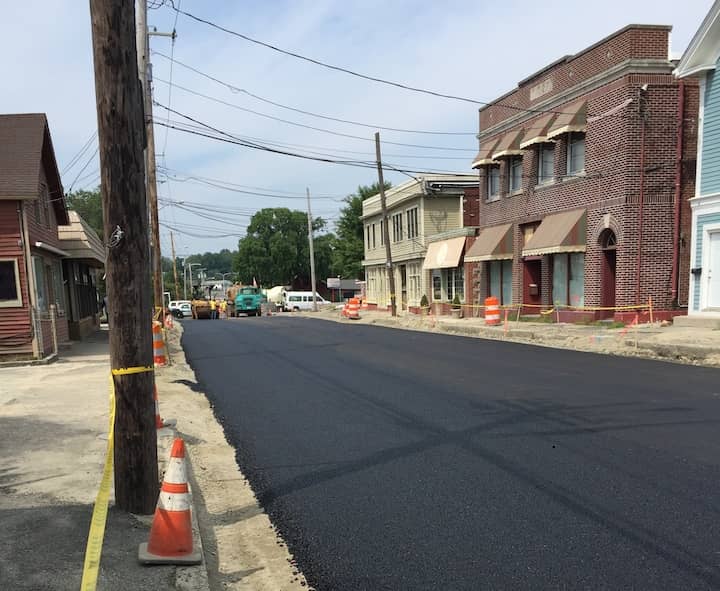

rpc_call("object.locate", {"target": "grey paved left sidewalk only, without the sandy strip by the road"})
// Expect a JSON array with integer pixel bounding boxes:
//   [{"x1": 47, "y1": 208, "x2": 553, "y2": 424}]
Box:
[{"x1": 0, "y1": 327, "x2": 208, "y2": 591}]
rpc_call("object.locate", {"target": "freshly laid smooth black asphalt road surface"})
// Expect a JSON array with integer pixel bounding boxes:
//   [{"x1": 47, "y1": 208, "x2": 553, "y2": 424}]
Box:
[{"x1": 183, "y1": 315, "x2": 720, "y2": 590}]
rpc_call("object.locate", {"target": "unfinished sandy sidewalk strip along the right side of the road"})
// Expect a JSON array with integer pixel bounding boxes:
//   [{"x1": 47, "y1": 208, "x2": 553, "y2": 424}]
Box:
[{"x1": 312, "y1": 309, "x2": 720, "y2": 367}]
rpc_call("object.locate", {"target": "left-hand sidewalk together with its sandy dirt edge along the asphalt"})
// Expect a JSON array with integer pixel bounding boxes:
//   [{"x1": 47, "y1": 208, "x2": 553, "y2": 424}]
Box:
[{"x1": 0, "y1": 323, "x2": 308, "y2": 591}]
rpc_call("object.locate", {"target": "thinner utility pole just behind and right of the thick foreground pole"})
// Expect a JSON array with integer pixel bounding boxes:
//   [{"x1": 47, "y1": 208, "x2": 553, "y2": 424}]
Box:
[{"x1": 136, "y1": 0, "x2": 164, "y2": 311}]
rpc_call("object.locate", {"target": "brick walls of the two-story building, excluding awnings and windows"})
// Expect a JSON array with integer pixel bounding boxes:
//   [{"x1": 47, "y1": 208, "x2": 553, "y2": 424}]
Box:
[{"x1": 466, "y1": 25, "x2": 699, "y2": 320}]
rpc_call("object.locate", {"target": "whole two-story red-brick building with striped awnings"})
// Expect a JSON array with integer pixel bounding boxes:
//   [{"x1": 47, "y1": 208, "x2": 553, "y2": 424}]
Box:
[{"x1": 464, "y1": 25, "x2": 698, "y2": 317}]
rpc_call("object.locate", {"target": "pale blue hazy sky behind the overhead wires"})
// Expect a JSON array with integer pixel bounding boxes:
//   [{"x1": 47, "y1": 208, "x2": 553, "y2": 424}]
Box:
[{"x1": 0, "y1": 0, "x2": 712, "y2": 256}]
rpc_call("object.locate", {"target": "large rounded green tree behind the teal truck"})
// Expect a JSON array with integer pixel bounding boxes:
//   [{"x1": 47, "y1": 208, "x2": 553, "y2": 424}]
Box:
[{"x1": 234, "y1": 207, "x2": 334, "y2": 287}]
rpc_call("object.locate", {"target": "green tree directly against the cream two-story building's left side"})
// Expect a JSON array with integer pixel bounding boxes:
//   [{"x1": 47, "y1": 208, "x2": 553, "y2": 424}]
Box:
[{"x1": 332, "y1": 181, "x2": 392, "y2": 279}]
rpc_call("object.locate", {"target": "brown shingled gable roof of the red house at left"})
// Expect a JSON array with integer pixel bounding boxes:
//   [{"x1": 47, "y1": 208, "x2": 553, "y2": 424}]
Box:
[{"x1": 0, "y1": 113, "x2": 69, "y2": 225}]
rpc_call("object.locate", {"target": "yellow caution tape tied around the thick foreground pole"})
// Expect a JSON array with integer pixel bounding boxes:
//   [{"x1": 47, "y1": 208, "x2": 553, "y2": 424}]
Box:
[{"x1": 80, "y1": 367, "x2": 154, "y2": 591}]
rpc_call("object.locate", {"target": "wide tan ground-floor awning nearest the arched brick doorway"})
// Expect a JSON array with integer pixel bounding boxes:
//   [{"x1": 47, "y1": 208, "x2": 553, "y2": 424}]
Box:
[{"x1": 523, "y1": 209, "x2": 586, "y2": 256}]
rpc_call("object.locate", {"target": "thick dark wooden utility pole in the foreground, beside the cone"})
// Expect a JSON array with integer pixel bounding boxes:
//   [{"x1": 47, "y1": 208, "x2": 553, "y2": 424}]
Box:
[{"x1": 90, "y1": 0, "x2": 158, "y2": 515}]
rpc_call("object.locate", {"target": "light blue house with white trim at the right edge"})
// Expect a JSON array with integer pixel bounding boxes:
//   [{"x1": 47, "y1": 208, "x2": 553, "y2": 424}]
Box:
[{"x1": 675, "y1": 0, "x2": 720, "y2": 317}]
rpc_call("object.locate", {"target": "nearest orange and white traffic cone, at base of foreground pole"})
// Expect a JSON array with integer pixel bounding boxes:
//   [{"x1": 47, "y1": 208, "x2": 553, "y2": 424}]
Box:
[{"x1": 138, "y1": 437, "x2": 202, "y2": 564}]
